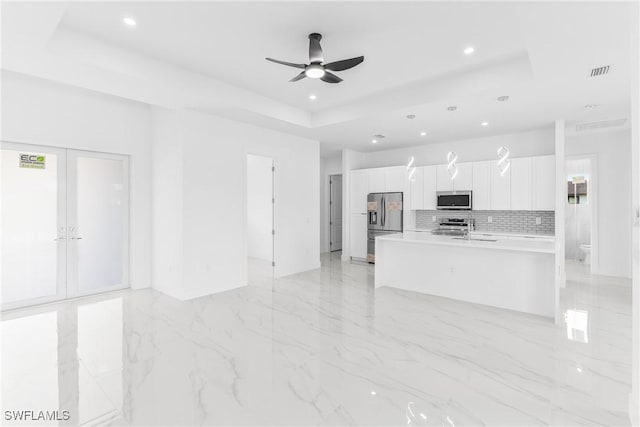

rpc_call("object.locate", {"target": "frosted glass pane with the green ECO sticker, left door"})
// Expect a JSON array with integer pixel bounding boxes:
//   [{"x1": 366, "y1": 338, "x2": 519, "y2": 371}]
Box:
[{"x1": 0, "y1": 149, "x2": 59, "y2": 303}]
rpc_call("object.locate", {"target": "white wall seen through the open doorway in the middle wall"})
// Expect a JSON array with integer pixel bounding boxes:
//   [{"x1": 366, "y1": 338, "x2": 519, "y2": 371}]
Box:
[{"x1": 247, "y1": 155, "x2": 273, "y2": 262}]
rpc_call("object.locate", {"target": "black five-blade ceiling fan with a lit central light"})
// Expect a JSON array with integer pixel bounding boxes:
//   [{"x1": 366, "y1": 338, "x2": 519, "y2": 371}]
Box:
[{"x1": 265, "y1": 33, "x2": 364, "y2": 83}]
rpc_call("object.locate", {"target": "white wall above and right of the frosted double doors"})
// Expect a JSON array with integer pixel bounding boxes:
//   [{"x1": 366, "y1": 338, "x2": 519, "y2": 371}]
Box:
[{"x1": 0, "y1": 70, "x2": 151, "y2": 288}]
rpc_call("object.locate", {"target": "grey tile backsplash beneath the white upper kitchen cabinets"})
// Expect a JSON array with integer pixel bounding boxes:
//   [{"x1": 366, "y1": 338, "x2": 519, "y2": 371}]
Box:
[{"x1": 416, "y1": 210, "x2": 555, "y2": 236}]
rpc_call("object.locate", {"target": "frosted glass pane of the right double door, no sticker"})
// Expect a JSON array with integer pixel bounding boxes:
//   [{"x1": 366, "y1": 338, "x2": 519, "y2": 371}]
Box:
[{"x1": 73, "y1": 157, "x2": 127, "y2": 293}]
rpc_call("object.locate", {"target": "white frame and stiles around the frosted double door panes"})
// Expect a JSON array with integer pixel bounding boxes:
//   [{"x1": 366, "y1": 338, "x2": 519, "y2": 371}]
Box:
[{"x1": 0, "y1": 140, "x2": 132, "y2": 312}]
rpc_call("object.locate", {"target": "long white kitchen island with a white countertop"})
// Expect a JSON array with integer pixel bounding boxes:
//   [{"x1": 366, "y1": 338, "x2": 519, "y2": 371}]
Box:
[{"x1": 375, "y1": 231, "x2": 556, "y2": 317}]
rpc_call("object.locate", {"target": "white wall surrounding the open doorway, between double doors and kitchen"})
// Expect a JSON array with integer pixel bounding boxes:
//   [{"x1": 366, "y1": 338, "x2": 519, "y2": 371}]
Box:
[{"x1": 152, "y1": 108, "x2": 320, "y2": 299}]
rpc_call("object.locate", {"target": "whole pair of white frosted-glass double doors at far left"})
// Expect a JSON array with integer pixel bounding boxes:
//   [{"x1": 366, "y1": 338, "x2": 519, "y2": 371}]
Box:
[{"x1": 0, "y1": 142, "x2": 129, "y2": 310}]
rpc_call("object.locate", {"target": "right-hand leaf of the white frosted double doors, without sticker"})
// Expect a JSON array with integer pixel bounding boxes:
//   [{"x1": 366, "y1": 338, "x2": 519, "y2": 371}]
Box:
[{"x1": 67, "y1": 150, "x2": 129, "y2": 296}]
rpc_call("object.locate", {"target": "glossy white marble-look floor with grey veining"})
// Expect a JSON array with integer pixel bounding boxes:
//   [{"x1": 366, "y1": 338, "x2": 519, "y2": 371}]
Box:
[{"x1": 2, "y1": 255, "x2": 631, "y2": 426}]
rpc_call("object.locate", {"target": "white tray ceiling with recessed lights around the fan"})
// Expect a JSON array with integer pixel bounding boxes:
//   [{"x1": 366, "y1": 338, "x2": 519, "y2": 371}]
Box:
[{"x1": 2, "y1": 1, "x2": 631, "y2": 153}]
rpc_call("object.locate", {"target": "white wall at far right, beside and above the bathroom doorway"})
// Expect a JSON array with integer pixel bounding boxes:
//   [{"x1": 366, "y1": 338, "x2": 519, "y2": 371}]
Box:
[{"x1": 566, "y1": 131, "x2": 632, "y2": 277}]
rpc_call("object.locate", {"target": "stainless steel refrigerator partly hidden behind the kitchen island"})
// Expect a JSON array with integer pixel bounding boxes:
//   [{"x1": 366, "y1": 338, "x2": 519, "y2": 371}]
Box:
[{"x1": 367, "y1": 193, "x2": 402, "y2": 264}]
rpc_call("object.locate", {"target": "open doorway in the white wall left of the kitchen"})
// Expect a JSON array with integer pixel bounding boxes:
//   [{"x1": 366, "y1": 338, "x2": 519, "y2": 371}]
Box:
[{"x1": 247, "y1": 154, "x2": 275, "y2": 284}]
